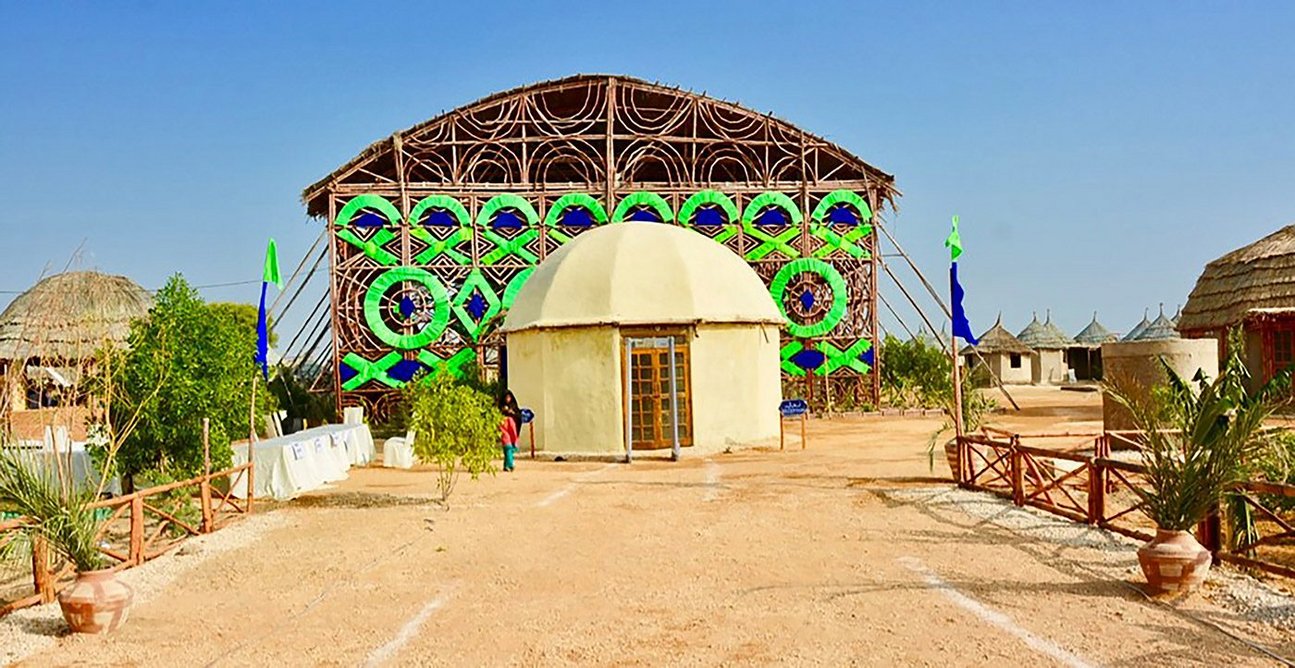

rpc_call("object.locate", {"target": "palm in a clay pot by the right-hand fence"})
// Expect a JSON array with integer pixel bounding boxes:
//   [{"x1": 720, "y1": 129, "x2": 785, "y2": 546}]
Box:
[{"x1": 1106, "y1": 342, "x2": 1289, "y2": 592}]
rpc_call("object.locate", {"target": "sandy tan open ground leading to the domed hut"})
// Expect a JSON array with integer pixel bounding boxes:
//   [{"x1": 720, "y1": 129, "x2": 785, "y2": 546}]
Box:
[{"x1": 10, "y1": 390, "x2": 1295, "y2": 665}]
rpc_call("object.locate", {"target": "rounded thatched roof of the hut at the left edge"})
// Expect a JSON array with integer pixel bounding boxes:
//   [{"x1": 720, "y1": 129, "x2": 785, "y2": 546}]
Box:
[{"x1": 0, "y1": 272, "x2": 153, "y2": 360}]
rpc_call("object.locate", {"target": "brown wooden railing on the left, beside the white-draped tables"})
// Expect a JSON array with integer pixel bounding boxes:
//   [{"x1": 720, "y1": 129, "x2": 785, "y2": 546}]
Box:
[{"x1": 0, "y1": 462, "x2": 253, "y2": 616}]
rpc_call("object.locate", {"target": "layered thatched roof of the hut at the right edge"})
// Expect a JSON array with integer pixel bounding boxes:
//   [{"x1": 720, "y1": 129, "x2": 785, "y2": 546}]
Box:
[{"x1": 1178, "y1": 225, "x2": 1295, "y2": 331}]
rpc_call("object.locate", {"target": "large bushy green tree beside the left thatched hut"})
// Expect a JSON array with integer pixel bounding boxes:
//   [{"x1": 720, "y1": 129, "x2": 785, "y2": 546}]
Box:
[{"x1": 100, "y1": 274, "x2": 273, "y2": 487}]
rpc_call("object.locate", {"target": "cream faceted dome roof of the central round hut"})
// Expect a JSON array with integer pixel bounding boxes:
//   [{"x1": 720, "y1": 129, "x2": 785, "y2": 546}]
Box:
[{"x1": 502, "y1": 223, "x2": 785, "y2": 331}]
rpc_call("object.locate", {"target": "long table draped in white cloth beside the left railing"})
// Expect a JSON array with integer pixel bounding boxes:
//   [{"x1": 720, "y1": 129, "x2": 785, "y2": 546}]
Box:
[{"x1": 233, "y1": 425, "x2": 374, "y2": 500}]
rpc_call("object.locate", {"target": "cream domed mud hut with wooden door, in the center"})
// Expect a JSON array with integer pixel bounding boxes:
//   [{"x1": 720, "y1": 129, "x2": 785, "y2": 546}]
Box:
[{"x1": 501, "y1": 223, "x2": 785, "y2": 453}]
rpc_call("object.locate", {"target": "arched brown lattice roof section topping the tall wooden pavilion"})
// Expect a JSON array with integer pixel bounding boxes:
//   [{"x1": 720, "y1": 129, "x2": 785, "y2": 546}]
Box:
[{"x1": 302, "y1": 74, "x2": 899, "y2": 217}]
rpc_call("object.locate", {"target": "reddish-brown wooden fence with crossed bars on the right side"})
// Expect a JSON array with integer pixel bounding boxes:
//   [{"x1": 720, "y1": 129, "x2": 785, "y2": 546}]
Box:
[{"x1": 949, "y1": 429, "x2": 1295, "y2": 577}]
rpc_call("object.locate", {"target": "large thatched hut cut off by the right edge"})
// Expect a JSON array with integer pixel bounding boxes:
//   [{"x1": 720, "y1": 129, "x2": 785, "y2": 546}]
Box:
[{"x1": 1177, "y1": 225, "x2": 1295, "y2": 383}]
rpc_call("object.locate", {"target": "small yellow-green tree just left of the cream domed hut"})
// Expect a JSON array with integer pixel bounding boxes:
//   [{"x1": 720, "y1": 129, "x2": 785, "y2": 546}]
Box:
[{"x1": 405, "y1": 373, "x2": 504, "y2": 502}]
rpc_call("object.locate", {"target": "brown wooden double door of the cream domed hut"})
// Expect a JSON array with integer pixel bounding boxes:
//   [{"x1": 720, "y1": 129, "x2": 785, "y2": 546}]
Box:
[{"x1": 625, "y1": 335, "x2": 693, "y2": 451}]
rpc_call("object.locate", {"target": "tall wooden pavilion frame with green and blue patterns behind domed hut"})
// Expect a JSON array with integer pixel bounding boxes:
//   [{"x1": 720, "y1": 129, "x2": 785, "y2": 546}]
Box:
[{"x1": 303, "y1": 75, "x2": 899, "y2": 417}]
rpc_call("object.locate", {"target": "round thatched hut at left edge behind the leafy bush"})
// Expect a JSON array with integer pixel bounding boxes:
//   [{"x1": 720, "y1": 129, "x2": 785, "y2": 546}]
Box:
[{"x1": 0, "y1": 272, "x2": 153, "y2": 429}]
